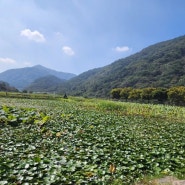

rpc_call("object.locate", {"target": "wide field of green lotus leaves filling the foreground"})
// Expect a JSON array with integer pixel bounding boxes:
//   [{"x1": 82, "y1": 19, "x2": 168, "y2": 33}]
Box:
[{"x1": 0, "y1": 97, "x2": 185, "y2": 185}]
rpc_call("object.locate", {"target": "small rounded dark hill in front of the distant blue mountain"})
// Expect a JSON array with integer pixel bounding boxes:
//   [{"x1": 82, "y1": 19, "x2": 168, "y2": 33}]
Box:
[{"x1": 25, "y1": 75, "x2": 66, "y2": 92}]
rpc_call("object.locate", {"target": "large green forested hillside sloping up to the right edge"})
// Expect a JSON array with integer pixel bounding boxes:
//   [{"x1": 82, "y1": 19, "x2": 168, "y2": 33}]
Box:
[{"x1": 58, "y1": 36, "x2": 185, "y2": 97}]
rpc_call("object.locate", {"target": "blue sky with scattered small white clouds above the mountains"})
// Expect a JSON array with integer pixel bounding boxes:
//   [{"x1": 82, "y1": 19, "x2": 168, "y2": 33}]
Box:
[{"x1": 0, "y1": 0, "x2": 185, "y2": 74}]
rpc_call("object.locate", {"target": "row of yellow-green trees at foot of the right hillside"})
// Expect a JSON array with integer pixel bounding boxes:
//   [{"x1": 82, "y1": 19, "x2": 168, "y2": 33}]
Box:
[{"x1": 111, "y1": 86, "x2": 185, "y2": 106}]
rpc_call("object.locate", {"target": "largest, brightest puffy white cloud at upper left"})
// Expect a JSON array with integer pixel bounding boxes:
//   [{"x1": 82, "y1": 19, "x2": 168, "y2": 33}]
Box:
[{"x1": 21, "y1": 29, "x2": 46, "y2": 42}]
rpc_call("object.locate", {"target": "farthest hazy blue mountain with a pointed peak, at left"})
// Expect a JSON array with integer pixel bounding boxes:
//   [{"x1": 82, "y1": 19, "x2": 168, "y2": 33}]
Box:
[{"x1": 0, "y1": 65, "x2": 76, "y2": 90}]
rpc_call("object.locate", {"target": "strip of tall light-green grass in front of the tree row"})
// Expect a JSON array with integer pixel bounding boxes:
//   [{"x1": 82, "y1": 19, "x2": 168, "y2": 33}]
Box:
[{"x1": 96, "y1": 100, "x2": 185, "y2": 122}]
